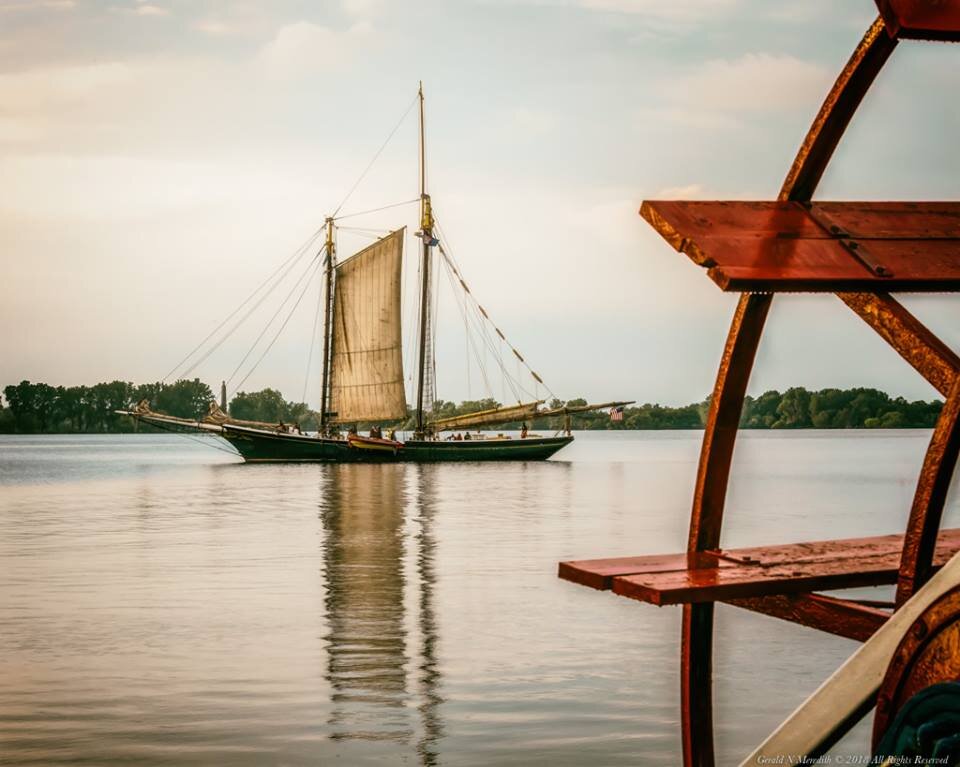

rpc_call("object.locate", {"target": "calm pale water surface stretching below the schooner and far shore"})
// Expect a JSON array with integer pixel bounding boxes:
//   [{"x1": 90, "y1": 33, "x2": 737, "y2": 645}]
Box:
[{"x1": 0, "y1": 431, "x2": 958, "y2": 766}]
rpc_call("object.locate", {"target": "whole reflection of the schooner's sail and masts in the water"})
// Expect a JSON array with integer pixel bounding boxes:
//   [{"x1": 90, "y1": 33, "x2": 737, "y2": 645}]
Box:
[{"x1": 320, "y1": 464, "x2": 443, "y2": 765}]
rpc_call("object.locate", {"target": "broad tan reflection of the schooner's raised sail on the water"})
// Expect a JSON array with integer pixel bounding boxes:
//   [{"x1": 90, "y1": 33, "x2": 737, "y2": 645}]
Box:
[{"x1": 321, "y1": 464, "x2": 412, "y2": 742}]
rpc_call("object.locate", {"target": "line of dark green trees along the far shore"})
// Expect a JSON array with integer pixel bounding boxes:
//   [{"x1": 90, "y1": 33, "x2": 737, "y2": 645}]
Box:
[{"x1": 0, "y1": 378, "x2": 943, "y2": 434}]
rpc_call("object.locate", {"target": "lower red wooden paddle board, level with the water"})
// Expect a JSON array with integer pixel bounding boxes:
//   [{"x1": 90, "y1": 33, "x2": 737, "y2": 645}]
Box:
[{"x1": 559, "y1": 529, "x2": 960, "y2": 605}]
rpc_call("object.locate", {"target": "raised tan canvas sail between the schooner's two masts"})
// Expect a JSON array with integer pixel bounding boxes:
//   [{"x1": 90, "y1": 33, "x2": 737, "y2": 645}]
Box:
[{"x1": 330, "y1": 229, "x2": 407, "y2": 423}]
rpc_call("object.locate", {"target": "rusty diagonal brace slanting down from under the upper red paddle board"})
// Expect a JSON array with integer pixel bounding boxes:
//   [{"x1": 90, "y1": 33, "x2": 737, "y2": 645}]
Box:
[{"x1": 837, "y1": 293, "x2": 960, "y2": 396}]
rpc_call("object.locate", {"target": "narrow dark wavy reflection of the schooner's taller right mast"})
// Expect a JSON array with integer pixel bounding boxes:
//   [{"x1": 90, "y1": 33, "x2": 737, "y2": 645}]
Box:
[{"x1": 416, "y1": 464, "x2": 443, "y2": 767}]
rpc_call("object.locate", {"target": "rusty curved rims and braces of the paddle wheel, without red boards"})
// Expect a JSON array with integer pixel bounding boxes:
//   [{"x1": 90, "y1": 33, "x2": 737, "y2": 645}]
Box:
[{"x1": 681, "y1": 17, "x2": 960, "y2": 767}]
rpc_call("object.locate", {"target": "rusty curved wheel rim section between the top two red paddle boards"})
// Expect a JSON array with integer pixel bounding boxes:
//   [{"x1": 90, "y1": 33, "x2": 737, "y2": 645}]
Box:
[{"x1": 779, "y1": 17, "x2": 897, "y2": 201}]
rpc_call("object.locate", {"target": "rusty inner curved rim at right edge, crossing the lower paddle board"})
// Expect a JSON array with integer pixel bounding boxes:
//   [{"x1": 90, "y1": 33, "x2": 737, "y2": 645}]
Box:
[{"x1": 896, "y1": 377, "x2": 960, "y2": 607}]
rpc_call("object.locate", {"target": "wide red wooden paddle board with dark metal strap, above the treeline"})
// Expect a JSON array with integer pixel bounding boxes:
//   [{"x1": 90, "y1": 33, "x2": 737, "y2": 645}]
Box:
[{"x1": 640, "y1": 200, "x2": 960, "y2": 292}]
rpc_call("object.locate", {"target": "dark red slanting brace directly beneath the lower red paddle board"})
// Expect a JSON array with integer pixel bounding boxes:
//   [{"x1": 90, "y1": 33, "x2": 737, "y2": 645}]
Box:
[{"x1": 727, "y1": 594, "x2": 890, "y2": 642}]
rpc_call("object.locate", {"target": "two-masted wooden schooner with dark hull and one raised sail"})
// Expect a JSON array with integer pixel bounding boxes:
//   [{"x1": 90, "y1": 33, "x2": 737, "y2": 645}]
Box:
[{"x1": 122, "y1": 84, "x2": 631, "y2": 463}]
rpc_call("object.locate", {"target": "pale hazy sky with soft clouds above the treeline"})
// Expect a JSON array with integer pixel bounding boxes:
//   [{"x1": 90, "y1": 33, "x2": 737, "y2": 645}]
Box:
[{"x1": 0, "y1": 0, "x2": 960, "y2": 406}]
